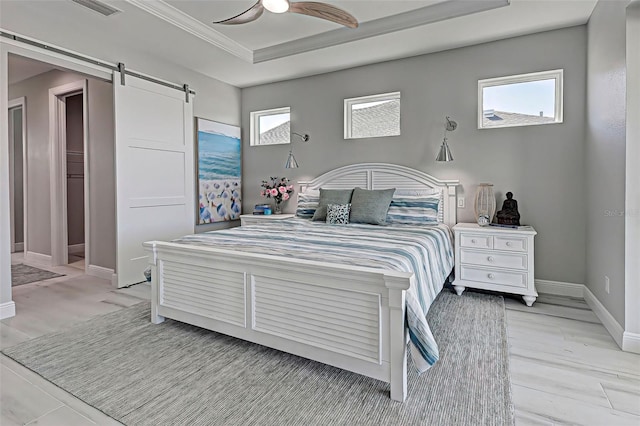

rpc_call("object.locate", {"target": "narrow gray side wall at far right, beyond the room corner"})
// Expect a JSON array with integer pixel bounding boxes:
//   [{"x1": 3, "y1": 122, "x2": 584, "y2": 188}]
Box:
[{"x1": 585, "y1": 1, "x2": 628, "y2": 327}]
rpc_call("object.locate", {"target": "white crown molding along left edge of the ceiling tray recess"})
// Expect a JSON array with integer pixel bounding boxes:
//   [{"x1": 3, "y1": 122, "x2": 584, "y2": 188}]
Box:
[{"x1": 125, "y1": 0, "x2": 253, "y2": 63}]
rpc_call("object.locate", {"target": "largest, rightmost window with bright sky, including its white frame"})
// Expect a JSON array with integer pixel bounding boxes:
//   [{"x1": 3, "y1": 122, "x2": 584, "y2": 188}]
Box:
[{"x1": 478, "y1": 70, "x2": 563, "y2": 129}]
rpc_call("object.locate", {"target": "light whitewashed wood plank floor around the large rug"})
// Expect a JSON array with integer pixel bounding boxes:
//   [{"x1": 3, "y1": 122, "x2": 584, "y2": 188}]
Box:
[{"x1": 0, "y1": 257, "x2": 640, "y2": 426}]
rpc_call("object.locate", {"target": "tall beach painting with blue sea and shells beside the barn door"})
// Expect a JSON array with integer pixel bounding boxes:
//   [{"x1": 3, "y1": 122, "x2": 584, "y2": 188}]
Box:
[{"x1": 196, "y1": 118, "x2": 242, "y2": 225}]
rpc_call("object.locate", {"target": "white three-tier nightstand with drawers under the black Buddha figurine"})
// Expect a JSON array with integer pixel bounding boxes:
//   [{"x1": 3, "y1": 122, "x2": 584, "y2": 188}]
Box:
[{"x1": 453, "y1": 223, "x2": 538, "y2": 306}]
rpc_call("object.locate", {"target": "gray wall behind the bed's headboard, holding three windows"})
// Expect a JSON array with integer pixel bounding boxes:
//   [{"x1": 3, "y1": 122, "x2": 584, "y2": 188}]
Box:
[{"x1": 242, "y1": 26, "x2": 587, "y2": 283}]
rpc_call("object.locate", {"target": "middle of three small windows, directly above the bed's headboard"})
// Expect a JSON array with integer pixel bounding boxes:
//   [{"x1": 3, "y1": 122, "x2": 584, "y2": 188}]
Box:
[{"x1": 344, "y1": 92, "x2": 400, "y2": 139}]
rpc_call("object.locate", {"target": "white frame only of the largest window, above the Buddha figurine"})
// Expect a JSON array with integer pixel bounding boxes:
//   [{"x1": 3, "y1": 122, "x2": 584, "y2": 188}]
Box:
[{"x1": 478, "y1": 69, "x2": 564, "y2": 130}]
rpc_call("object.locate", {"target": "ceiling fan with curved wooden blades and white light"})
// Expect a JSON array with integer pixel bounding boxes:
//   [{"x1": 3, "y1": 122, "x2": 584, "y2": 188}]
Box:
[{"x1": 214, "y1": 0, "x2": 358, "y2": 28}]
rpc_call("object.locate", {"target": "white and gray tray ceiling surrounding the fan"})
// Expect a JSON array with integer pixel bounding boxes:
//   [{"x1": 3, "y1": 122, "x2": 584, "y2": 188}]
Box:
[{"x1": 0, "y1": 0, "x2": 597, "y2": 87}]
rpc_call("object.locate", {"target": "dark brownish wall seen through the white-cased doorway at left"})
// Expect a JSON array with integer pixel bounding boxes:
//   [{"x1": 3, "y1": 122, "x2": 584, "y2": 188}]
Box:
[{"x1": 65, "y1": 94, "x2": 85, "y2": 245}]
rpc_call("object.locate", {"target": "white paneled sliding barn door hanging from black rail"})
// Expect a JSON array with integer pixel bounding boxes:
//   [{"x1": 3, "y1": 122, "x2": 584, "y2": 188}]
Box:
[{"x1": 113, "y1": 72, "x2": 195, "y2": 287}]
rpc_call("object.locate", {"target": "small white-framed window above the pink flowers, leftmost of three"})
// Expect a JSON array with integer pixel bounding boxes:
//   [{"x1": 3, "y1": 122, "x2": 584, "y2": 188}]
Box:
[{"x1": 249, "y1": 107, "x2": 291, "y2": 146}]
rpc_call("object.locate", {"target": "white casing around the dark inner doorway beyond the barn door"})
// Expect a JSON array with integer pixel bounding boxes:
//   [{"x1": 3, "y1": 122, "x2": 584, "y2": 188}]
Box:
[{"x1": 49, "y1": 79, "x2": 91, "y2": 266}]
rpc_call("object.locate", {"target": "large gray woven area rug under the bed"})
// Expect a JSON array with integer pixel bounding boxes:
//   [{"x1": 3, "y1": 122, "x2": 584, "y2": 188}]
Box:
[{"x1": 4, "y1": 289, "x2": 514, "y2": 426}]
